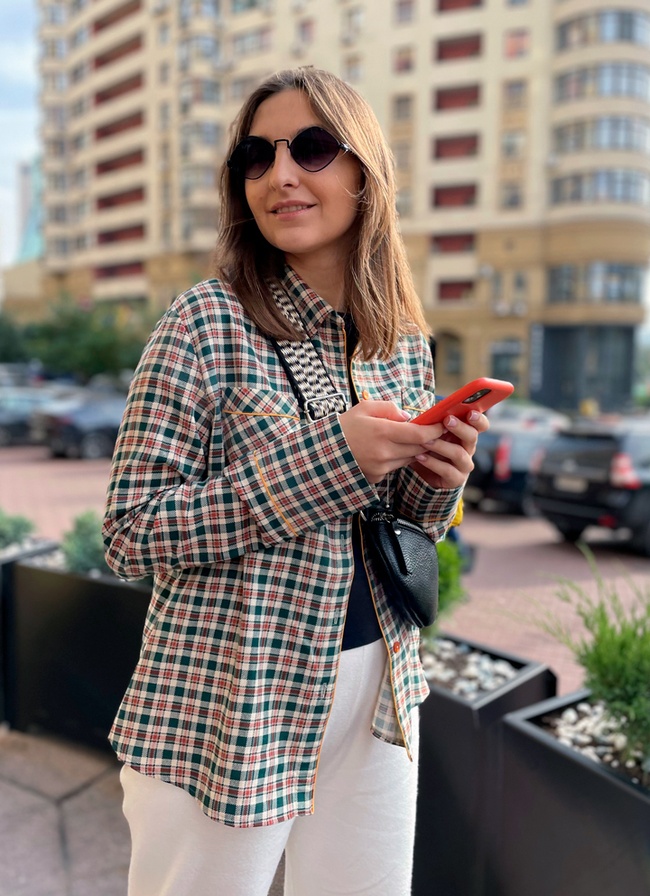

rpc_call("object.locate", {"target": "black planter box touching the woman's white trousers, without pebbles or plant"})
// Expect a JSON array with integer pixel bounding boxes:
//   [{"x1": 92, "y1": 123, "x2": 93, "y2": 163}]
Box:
[{"x1": 411, "y1": 634, "x2": 556, "y2": 896}]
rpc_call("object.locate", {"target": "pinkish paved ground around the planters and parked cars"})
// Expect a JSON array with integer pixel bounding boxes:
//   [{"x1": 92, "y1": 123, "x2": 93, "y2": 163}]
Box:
[{"x1": 0, "y1": 448, "x2": 649, "y2": 896}]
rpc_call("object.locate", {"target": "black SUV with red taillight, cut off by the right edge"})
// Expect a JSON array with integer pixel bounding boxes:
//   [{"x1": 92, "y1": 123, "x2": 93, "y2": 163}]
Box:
[{"x1": 531, "y1": 415, "x2": 650, "y2": 556}]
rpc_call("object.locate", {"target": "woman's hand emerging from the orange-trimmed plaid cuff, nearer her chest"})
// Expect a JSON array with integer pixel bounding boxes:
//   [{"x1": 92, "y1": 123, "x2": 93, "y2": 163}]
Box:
[{"x1": 339, "y1": 401, "x2": 442, "y2": 483}]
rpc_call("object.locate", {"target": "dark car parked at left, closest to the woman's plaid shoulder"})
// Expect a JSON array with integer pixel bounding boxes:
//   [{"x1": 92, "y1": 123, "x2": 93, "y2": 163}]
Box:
[{"x1": 36, "y1": 393, "x2": 126, "y2": 460}]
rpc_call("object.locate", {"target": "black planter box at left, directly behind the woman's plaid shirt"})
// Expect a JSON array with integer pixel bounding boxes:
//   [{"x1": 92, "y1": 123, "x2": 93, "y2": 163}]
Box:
[{"x1": 5, "y1": 562, "x2": 151, "y2": 748}]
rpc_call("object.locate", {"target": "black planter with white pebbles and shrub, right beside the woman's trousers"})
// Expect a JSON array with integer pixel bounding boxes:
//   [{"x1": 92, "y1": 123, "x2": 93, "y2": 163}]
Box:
[{"x1": 412, "y1": 541, "x2": 556, "y2": 896}]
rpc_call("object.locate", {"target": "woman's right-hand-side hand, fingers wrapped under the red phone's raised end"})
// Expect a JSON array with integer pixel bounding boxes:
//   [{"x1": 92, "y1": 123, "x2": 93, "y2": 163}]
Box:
[{"x1": 410, "y1": 411, "x2": 490, "y2": 488}]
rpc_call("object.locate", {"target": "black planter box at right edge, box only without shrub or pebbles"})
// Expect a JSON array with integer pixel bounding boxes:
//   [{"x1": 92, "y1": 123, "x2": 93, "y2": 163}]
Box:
[{"x1": 499, "y1": 691, "x2": 650, "y2": 896}]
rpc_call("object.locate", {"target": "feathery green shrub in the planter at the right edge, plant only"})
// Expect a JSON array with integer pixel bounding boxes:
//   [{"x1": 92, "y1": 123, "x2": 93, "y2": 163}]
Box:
[{"x1": 541, "y1": 546, "x2": 650, "y2": 786}]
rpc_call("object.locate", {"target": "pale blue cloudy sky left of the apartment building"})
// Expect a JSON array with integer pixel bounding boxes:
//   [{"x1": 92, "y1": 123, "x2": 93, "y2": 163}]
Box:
[{"x1": 0, "y1": 0, "x2": 38, "y2": 267}]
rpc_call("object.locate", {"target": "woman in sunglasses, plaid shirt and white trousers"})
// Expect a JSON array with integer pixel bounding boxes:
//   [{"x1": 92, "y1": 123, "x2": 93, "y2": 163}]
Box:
[{"x1": 104, "y1": 68, "x2": 487, "y2": 896}]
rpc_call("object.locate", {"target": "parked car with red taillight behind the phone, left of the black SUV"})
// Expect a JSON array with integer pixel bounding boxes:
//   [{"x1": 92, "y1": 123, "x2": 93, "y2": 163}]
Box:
[{"x1": 465, "y1": 412, "x2": 570, "y2": 514}]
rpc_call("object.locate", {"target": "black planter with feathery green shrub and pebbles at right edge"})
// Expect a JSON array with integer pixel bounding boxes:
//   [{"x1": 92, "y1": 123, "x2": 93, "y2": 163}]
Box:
[{"x1": 497, "y1": 554, "x2": 650, "y2": 896}]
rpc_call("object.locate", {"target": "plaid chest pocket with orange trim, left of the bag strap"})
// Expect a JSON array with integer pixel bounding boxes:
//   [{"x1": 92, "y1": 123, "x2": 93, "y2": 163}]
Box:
[{"x1": 222, "y1": 387, "x2": 300, "y2": 460}]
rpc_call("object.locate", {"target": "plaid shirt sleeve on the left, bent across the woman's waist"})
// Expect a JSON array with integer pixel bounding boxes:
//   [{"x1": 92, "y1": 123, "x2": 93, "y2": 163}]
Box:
[{"x1": 103, "y1": 313, "x2": 374, "y2": 578}]
